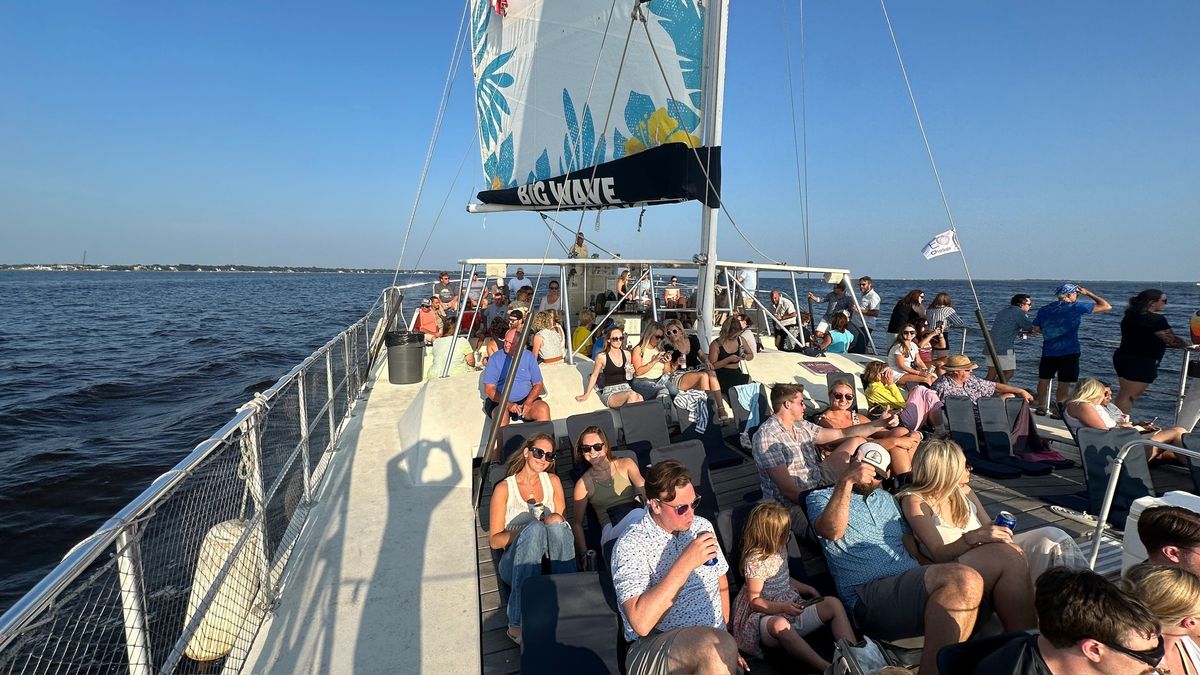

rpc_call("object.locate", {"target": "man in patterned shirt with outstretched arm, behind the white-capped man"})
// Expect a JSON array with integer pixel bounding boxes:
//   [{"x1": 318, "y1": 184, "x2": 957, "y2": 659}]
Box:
[{"x1": 754, "y1": 382, "x2": 894, "y2": 538}]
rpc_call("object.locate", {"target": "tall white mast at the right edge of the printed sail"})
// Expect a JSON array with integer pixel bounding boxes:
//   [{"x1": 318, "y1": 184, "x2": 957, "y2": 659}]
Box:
[{"x1": 696, "y1": 0, "x2": 730, "y2": 345}]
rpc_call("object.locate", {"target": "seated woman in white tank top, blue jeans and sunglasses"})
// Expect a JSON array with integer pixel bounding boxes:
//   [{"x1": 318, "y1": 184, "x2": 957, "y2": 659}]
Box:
[{"x1": 487, "y1": 434, "x2": 575, "y2": 644}]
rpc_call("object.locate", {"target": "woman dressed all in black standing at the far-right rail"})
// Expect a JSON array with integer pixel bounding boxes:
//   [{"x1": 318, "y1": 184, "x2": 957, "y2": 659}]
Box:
[{"x1": 1112, "y1": 288, "x2": 1188, "y2": 414}]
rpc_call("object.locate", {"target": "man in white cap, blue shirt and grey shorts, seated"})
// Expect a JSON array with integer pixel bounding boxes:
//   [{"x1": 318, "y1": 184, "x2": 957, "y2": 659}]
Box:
[{"x1": 808, "y1": 443, "x2": 1037, "y2": 675}]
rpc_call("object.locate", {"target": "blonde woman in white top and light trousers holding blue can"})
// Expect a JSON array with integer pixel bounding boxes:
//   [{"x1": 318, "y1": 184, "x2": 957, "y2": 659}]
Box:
[{"x1": 896, "y1": 438, "x2": 1087, "y2": 583}]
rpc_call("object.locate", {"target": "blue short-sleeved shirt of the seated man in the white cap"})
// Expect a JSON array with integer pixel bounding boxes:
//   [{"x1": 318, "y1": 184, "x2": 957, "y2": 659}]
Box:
[{"x1": 808, "y1": 488, "x2": 919, "y2": 609}]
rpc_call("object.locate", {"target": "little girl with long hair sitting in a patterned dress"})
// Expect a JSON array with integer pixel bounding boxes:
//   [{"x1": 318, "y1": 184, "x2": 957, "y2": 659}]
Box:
[{"x1": 731, "y1": 502, "x2": 858, "y2": 673}]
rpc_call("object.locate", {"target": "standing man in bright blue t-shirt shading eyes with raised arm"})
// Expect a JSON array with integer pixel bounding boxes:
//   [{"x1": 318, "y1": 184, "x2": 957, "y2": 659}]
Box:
[{"x1": 1033, "y1": 281, "x2": 1112, "y2": 414}]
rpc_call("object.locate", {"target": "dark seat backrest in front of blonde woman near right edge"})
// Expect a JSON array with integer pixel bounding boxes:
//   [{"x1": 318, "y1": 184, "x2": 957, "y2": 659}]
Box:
[{"x1": 1079, "y1": 428, "x2": 1154, "y2": 527}]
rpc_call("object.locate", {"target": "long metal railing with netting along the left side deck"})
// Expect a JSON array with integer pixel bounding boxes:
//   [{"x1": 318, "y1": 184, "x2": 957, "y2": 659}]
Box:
[{"x1": 0, "y1": 288, "x2": 401, "y2": 675}]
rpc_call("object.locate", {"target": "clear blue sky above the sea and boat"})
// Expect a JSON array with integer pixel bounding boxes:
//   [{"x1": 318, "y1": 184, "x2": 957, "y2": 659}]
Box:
[{"x1": 0, "y1": 0, "x2": 1200, "y2": 281}]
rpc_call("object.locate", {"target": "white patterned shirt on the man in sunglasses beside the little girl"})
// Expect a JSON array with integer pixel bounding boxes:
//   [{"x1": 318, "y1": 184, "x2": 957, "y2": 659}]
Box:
[{"x1": 612, "y1": 510, "x2": 730, "y2": 641}]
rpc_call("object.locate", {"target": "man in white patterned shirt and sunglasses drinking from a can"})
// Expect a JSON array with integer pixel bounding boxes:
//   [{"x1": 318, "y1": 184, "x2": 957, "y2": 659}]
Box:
[{"x1": 612, "y1": 460, "x2": 745, "y2": 675}]
